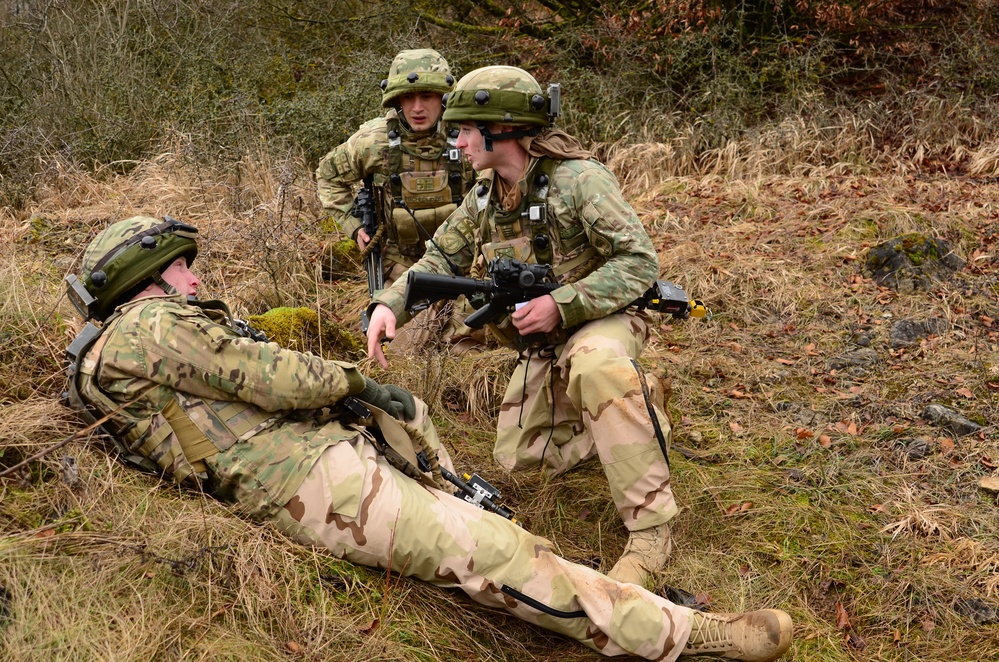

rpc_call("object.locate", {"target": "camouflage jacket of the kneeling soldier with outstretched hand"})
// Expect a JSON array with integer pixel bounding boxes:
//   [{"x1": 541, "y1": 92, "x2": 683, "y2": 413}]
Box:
[{"x1": 372, "y1": 158, "x2": 659, "y2": 344}]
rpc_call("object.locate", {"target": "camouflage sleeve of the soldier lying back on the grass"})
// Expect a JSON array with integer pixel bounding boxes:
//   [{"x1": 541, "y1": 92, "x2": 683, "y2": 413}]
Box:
[{"x1": 111, "y1": 300, "x2": 364, "y2": 411}]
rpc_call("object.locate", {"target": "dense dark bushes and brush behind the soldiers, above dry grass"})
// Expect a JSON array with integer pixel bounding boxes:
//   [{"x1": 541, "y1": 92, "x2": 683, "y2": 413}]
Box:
[{"x1": 0, "y1": 0, "x2": 999, "y2": 209}]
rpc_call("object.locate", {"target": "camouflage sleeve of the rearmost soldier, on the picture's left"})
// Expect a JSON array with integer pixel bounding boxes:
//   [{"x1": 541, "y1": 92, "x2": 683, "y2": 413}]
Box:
[{"x1": 316, "y1": 117, "x2": 388, "y2": 239}]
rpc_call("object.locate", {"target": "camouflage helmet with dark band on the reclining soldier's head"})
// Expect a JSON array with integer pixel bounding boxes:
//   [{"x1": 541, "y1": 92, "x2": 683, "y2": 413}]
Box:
[{"x1": 81, "y1": 216, "x2": 198, "y2": 320}]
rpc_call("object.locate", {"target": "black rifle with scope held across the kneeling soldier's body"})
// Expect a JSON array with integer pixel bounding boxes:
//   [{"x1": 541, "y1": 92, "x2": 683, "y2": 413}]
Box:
[{"x1": 403, "y1": 258, "x2": 707, "y2": 329}]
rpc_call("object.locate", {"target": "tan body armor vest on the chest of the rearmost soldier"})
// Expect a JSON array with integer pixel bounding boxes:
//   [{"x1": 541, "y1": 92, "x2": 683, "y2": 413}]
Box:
[{"x1": 382, "y1": 117, "x2": 465, "y2": 260}]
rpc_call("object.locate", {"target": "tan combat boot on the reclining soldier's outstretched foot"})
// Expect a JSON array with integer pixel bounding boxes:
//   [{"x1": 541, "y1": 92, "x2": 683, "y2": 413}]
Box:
[{"x1": 680, "y1": 609, "x2": 794, "y2": 662}]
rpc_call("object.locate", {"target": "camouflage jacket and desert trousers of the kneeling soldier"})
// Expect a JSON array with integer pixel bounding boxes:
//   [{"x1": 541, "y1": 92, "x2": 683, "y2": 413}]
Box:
[{"x1": 372, "y1": 160, "x2": 676, "y2": 530}]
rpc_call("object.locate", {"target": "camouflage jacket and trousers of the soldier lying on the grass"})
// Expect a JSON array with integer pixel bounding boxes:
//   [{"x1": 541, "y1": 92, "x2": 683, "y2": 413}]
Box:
[{"x1": 82, "y1": 296, "x2": 692, "y2": 660}]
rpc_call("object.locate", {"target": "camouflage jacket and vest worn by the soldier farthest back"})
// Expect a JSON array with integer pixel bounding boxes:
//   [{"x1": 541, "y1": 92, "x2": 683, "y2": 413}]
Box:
[{"x1": 316, "y1": 108, "x2": 473, "y2": 265}]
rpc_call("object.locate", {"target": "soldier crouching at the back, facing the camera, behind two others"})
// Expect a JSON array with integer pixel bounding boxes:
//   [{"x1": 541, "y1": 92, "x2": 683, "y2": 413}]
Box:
[{"x1": 316, "y1": 48, "x2": 481, "y2": 352}]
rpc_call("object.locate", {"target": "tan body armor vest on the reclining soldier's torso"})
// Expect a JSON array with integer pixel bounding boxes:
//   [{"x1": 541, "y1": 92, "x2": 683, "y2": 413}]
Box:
[{"x1": 67, "y1": 306, "x2": 281, "y2": 485}]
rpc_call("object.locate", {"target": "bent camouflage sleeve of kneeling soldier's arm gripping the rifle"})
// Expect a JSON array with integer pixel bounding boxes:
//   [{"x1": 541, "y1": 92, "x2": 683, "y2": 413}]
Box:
[{"x1": 552, "y1": 160, "x2": 659, "y2": 328}]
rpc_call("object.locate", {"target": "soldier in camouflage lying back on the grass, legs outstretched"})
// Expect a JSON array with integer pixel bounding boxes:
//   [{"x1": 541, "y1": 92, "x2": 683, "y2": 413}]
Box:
[{"x1": 67, "y1": 216, "x2": 792, "y2": 661}]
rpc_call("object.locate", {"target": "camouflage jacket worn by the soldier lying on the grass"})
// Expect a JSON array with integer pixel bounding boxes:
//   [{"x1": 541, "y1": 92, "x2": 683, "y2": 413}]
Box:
[{"x1": 81, "y1": 295, "x2": 372, "y2": 518}]
